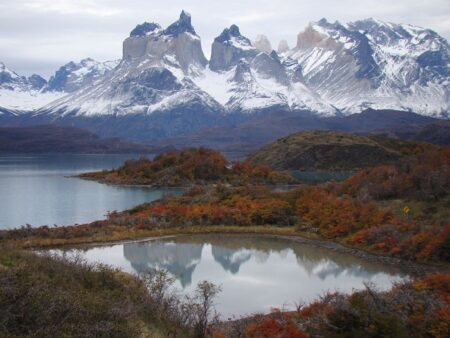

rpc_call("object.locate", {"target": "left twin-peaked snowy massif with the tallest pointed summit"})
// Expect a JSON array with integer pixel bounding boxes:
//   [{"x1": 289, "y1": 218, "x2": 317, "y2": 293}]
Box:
[{"x1": 43, "y1": 12, "x2": 221, "y2": 117}]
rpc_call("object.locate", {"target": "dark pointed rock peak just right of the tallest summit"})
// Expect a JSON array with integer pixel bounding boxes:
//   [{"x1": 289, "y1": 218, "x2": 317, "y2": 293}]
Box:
[{"x1": 209, "y1": 25, "x2": 259, "y2": 71}]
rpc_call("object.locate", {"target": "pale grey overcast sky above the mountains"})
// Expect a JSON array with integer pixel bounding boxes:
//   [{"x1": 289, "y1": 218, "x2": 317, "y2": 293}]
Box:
[{"x1": 0, "y1": 0, "x2": 450, "y2": 77}]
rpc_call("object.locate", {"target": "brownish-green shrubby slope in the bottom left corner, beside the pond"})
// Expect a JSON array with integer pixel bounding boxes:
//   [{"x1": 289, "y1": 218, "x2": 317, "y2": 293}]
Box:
[{"x1": 0, "y1": 247, "x2": 225, "y2": 337}]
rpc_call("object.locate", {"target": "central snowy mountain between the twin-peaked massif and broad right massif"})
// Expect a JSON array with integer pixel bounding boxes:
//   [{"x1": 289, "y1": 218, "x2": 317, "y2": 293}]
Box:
[{"x1": 192, "y1": 25, "x2": 336, "y2": 115}]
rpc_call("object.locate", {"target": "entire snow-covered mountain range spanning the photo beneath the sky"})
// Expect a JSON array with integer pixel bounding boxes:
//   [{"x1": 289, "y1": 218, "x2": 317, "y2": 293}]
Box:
[{"x1": 0, "y1": 11, "x2": 450, "y2": 141}]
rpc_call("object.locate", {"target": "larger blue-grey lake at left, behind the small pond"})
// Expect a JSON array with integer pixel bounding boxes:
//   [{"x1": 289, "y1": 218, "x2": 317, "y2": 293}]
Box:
[{"x1": 0, "y1": 154, "x2": 181, "y2": 229}]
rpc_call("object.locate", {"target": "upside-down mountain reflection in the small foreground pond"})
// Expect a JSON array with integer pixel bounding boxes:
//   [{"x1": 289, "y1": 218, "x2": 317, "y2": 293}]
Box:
[{"x1": 123, "y1": 235, "x2": 402, "y2": 288}]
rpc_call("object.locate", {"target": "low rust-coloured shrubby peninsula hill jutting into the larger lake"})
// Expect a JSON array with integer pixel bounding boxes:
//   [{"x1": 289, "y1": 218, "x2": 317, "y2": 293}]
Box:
[{"x1": 80, "y1": 148, "x2": 292, "y2": 186}]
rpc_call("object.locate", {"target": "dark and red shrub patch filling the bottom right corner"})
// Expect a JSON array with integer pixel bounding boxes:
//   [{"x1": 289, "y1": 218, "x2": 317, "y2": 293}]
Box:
[{"x1": 299, "y1": 273, "x2": 450, "y2": 337}]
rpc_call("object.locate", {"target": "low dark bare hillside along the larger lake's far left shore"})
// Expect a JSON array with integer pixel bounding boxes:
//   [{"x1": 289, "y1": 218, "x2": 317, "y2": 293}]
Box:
[{"x1": 0, "y1": 125, "x2": 155, "y2": 154}]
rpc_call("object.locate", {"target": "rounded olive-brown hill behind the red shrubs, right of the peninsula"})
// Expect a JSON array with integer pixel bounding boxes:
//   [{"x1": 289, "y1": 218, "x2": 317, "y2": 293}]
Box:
[{"x1": 250, "y1": 131, "x2": 417, "y2": 170}]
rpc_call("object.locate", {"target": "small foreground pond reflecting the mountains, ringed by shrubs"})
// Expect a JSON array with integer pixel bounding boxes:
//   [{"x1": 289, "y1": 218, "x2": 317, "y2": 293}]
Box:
[{"x1": 52, "y1": 234, "x2": 407, "y2": 318}]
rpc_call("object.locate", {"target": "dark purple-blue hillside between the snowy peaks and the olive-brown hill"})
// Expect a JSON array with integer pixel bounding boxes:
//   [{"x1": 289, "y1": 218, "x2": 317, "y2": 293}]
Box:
[{"x1": 152, "y1": 109, "x2": 436, "y2": 154}]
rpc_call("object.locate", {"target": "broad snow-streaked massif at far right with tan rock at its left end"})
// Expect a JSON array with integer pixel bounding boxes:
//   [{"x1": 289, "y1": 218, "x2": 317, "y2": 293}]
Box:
[{"x1": 283, "y1": 19, "x2": 450, "y2": 117}]
